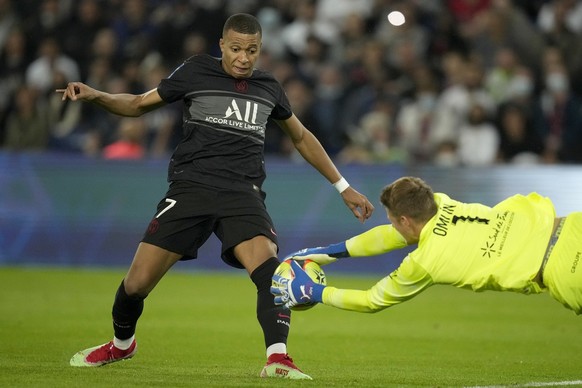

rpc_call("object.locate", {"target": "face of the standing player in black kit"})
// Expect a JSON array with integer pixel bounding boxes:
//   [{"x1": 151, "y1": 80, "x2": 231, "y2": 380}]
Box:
[{"x1": 220, "y1": 30, "x2": 261, "y2": 78}]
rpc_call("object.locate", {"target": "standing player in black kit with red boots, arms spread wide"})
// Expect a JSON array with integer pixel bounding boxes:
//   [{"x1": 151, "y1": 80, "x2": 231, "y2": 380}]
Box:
[{"x1": 57, "y1": 14, "x2": 374, "y2": 379}]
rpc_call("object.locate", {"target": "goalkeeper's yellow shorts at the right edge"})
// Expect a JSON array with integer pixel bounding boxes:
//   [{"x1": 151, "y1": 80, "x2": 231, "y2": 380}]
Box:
[{"x1": 543, "y1": 213, "x2": 582, "y2": 314}]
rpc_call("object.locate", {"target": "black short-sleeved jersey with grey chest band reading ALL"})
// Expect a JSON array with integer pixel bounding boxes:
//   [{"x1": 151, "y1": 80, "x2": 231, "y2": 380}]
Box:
[{"x1": 158, "y1": 55, "x2": 292, "y2": 188}]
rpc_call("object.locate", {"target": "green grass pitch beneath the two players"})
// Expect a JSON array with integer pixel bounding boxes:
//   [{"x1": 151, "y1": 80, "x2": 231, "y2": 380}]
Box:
[{"x1": 0, "y1": 266, "x2": 582, "y2": 388}]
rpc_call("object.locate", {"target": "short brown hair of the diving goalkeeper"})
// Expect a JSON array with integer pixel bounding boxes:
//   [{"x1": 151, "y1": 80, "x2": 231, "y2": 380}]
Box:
[{"x1": 380, "y1": 176, "x2": 438, "y2": 222}]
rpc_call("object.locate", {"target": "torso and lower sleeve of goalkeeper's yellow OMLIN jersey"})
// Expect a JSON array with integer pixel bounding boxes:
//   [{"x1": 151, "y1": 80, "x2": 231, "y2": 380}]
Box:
[{"x1": 323, "y1": 193, "x2": 556, "y2": 312}]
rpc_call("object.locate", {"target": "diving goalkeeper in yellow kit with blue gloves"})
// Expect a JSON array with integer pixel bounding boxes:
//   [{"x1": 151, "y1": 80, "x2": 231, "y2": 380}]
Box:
[{"x1": 271, "y1": 177, "x2": 582, "y2": 314}]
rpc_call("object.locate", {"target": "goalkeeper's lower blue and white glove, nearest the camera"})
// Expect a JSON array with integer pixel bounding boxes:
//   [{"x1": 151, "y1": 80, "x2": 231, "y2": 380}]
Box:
[{"x1": 271, "y1": 260, "x2": 325, "y2": 308}]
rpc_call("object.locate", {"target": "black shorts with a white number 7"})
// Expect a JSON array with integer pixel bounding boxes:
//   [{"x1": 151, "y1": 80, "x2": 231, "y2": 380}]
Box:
[{"x1": 142, "y1": 181, "x2": 278, "y2": 268}]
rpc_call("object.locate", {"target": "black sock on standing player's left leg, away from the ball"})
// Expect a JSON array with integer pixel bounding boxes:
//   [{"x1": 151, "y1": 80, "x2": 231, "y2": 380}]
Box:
[{"x1": 112, "y1": 281, "x2": 145, "y2": 340}]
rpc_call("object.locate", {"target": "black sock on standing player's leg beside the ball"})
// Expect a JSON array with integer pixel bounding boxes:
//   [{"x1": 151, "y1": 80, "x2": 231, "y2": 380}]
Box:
[{"x1": 251, "y1": 257, "x2": 291, "y2": 348}]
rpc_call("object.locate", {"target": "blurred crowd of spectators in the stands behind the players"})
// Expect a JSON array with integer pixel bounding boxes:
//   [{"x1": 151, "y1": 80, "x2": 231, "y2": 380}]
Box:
[{"x1": 0, "y1": 0, "x2": 582, "y2": 166}]
